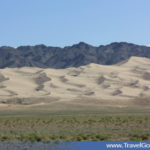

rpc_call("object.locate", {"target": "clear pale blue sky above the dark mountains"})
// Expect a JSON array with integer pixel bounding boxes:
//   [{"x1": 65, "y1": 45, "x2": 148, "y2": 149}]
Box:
[{"x1": 0, "y1": 0, "x2": 150, "y2": 47}]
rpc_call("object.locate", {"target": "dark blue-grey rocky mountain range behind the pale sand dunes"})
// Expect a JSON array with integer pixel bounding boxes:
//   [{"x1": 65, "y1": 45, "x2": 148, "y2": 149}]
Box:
[{"x1": 0, "y1": 42, "x2": 150, "y2": 69}]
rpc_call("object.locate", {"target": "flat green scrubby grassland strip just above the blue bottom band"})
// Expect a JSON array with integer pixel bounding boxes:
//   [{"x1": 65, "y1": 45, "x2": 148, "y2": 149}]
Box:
[{"x1": 0, "y1": 114, "x2": 150, "y2": 142}]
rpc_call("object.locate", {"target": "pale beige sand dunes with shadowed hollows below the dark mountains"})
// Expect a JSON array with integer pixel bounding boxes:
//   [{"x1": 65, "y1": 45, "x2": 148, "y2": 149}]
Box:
[{"x1": 0, "y1": 57, "x2": 150, "y2": 106}]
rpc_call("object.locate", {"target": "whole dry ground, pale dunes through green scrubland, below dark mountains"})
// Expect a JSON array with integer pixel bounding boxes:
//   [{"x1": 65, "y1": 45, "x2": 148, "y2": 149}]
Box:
[{"x1": 0, "y1": 57, "x2": 150, "y2": 141}]
